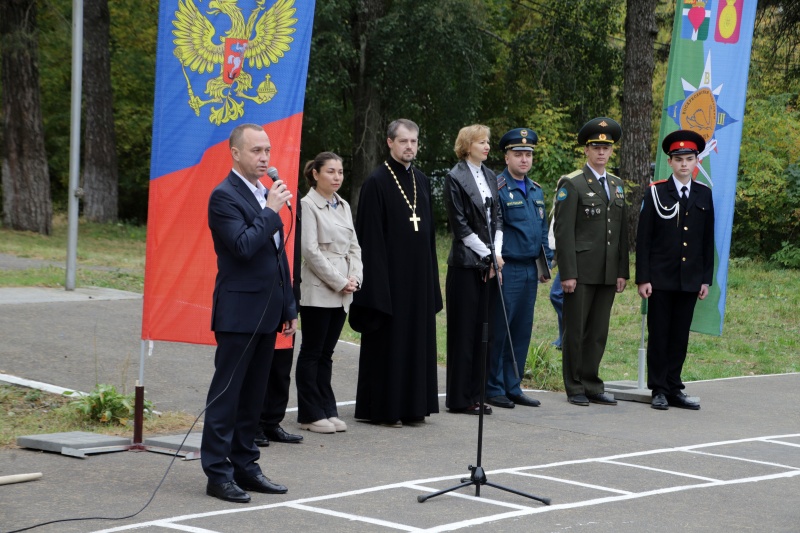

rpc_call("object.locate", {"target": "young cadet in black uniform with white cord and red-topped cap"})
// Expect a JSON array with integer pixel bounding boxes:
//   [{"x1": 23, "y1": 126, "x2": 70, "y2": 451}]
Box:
[{"x1": 636, "y1": 130, "x2": 714, "y2": 410}]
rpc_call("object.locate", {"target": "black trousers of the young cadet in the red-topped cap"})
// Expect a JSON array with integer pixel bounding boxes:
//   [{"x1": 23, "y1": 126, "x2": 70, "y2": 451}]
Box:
[{"x1": 647, "y1": 289, "x2": 697, "y2": 396}]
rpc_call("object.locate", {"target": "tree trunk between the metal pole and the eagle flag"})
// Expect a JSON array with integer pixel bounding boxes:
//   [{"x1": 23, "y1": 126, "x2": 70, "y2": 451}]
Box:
[{"x1": 83, "y1": 0, "x2": 119, "y2": 222}]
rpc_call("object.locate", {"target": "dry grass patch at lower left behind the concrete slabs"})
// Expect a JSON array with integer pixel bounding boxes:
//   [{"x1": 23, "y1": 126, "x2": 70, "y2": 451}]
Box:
[{"x1": 0, "y1": 385, "x2": 195, "y2": 448}]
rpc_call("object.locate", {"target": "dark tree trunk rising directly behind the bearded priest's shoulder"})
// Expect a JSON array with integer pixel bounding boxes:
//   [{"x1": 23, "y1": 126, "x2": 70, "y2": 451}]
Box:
[{"x1": 350, "y1": 0, "x2": 386, "y2": 216}]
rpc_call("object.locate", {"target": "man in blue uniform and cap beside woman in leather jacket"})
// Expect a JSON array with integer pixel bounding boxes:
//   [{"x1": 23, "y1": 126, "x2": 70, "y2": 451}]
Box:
[{"x1": 486, "y1": 128, "x2": 553, "y2": 408}]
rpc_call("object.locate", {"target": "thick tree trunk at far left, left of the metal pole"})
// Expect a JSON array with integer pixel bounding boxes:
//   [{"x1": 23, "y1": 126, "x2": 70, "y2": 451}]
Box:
[{"x1": 0, "y1": 0, "x2": 53, "y2": 235}]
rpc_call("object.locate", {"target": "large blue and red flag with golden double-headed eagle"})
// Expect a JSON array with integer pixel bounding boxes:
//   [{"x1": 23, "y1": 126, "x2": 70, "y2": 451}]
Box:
[{"x1": 142, "y1": 0, "x2": 314, "y2": 347}]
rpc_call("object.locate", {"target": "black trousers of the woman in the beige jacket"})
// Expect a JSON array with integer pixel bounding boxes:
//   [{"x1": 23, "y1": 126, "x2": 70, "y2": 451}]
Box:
[{"x1": 295, "y1": 305, "x2": 347, "y2": 424}]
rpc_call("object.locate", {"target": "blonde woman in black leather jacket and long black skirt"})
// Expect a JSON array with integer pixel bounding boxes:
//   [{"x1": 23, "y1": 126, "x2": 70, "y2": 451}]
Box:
[{"x1": 444, "y1": 124, "x2": 502, "y2": 414}]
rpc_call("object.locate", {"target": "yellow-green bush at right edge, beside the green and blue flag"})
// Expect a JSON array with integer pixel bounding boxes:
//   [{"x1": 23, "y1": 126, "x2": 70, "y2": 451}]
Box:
[{"x1": 731, "y1": 95, "x2": 800, "y2": 266}]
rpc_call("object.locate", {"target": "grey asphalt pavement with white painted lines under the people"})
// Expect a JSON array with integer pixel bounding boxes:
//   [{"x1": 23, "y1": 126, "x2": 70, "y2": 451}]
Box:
[{"x1": 0, "y1": 286, "x2": 800, "y2": 533}]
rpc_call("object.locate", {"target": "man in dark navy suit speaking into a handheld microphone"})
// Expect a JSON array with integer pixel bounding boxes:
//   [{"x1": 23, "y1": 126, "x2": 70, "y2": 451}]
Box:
[{"x1": 200, "y1": 124, "x2": 297, "y2": 503}]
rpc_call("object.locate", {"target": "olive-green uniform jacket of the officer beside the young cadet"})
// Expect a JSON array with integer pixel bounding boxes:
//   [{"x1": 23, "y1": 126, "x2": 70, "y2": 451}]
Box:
[{"x1": 554, "y1": 165, "x2": 630, "y2": 285}]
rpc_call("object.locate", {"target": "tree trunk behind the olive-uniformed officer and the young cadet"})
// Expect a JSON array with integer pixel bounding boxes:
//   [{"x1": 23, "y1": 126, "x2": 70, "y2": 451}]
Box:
[{"x1": 620, "y1": 0, "x2": 658, "y2": 249}]
